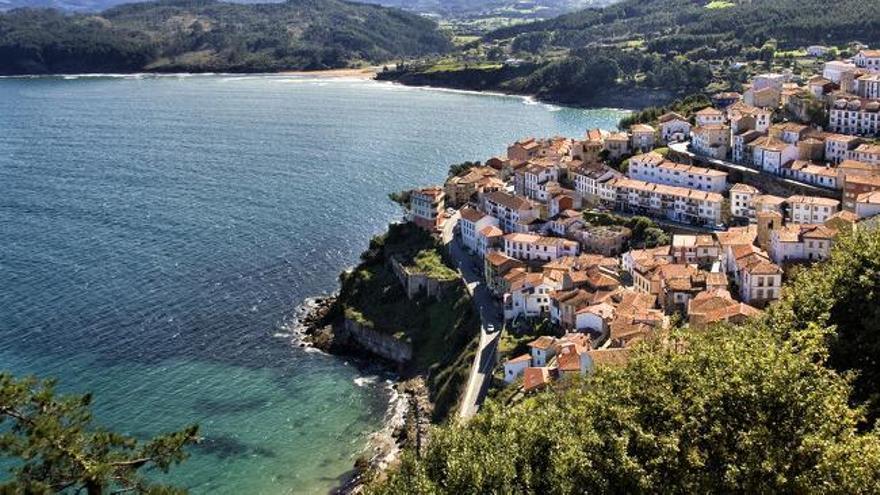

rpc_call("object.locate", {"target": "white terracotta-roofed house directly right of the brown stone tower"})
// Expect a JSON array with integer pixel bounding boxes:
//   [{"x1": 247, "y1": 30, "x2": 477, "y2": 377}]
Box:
[{"x1": 770, "y1": 224, "x2": 837, "y2": 265}]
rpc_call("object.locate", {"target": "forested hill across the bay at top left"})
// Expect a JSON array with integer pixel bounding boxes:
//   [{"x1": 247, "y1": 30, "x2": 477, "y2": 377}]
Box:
[{"x1": 0, "y1": 0, "x2": 451, "y2": 75}]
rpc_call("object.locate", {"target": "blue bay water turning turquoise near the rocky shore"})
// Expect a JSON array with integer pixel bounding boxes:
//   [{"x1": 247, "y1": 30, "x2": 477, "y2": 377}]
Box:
[{"x1": 0, "y1": 76, "x2": 622, "y2": 494}]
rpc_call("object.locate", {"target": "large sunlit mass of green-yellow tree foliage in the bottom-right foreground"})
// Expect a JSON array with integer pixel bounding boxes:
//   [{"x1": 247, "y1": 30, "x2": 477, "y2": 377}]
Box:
[{"x1": 369, "y1": 227, "x2": 880, "y2": 494}]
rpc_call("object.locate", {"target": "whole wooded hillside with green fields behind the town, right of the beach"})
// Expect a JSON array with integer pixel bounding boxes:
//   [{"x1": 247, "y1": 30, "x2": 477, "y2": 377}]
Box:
[{"x1": 382, "y1": 0, "x2": 880, "y2": 108}]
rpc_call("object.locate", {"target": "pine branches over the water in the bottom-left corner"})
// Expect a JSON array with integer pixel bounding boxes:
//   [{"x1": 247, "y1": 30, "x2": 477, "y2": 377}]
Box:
[{"x1": 0, "y1": 373, "x2": 198, "y2": 495}]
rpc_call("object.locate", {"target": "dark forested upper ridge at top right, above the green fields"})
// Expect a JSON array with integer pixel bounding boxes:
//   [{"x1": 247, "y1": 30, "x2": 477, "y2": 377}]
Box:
[{"x1": 487, "y1": 0, "x2": 880, "y2": 49}]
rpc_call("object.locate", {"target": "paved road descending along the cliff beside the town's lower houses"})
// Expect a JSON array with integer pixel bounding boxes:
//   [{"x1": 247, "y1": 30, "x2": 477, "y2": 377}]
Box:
[{"x1": 443, "y1": 213, "x2": 504, "y2": 419}]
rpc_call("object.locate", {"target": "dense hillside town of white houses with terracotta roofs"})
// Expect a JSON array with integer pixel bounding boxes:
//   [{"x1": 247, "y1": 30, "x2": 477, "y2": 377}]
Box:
[{"x1": 408, "y1": 50, "x2": 880, "y2": 392}]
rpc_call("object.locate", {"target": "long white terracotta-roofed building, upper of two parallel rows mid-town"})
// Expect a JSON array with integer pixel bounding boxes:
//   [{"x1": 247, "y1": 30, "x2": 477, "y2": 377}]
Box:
[{"x1": 627, "y1": 151, "x2": 727, "y2": 193}]
